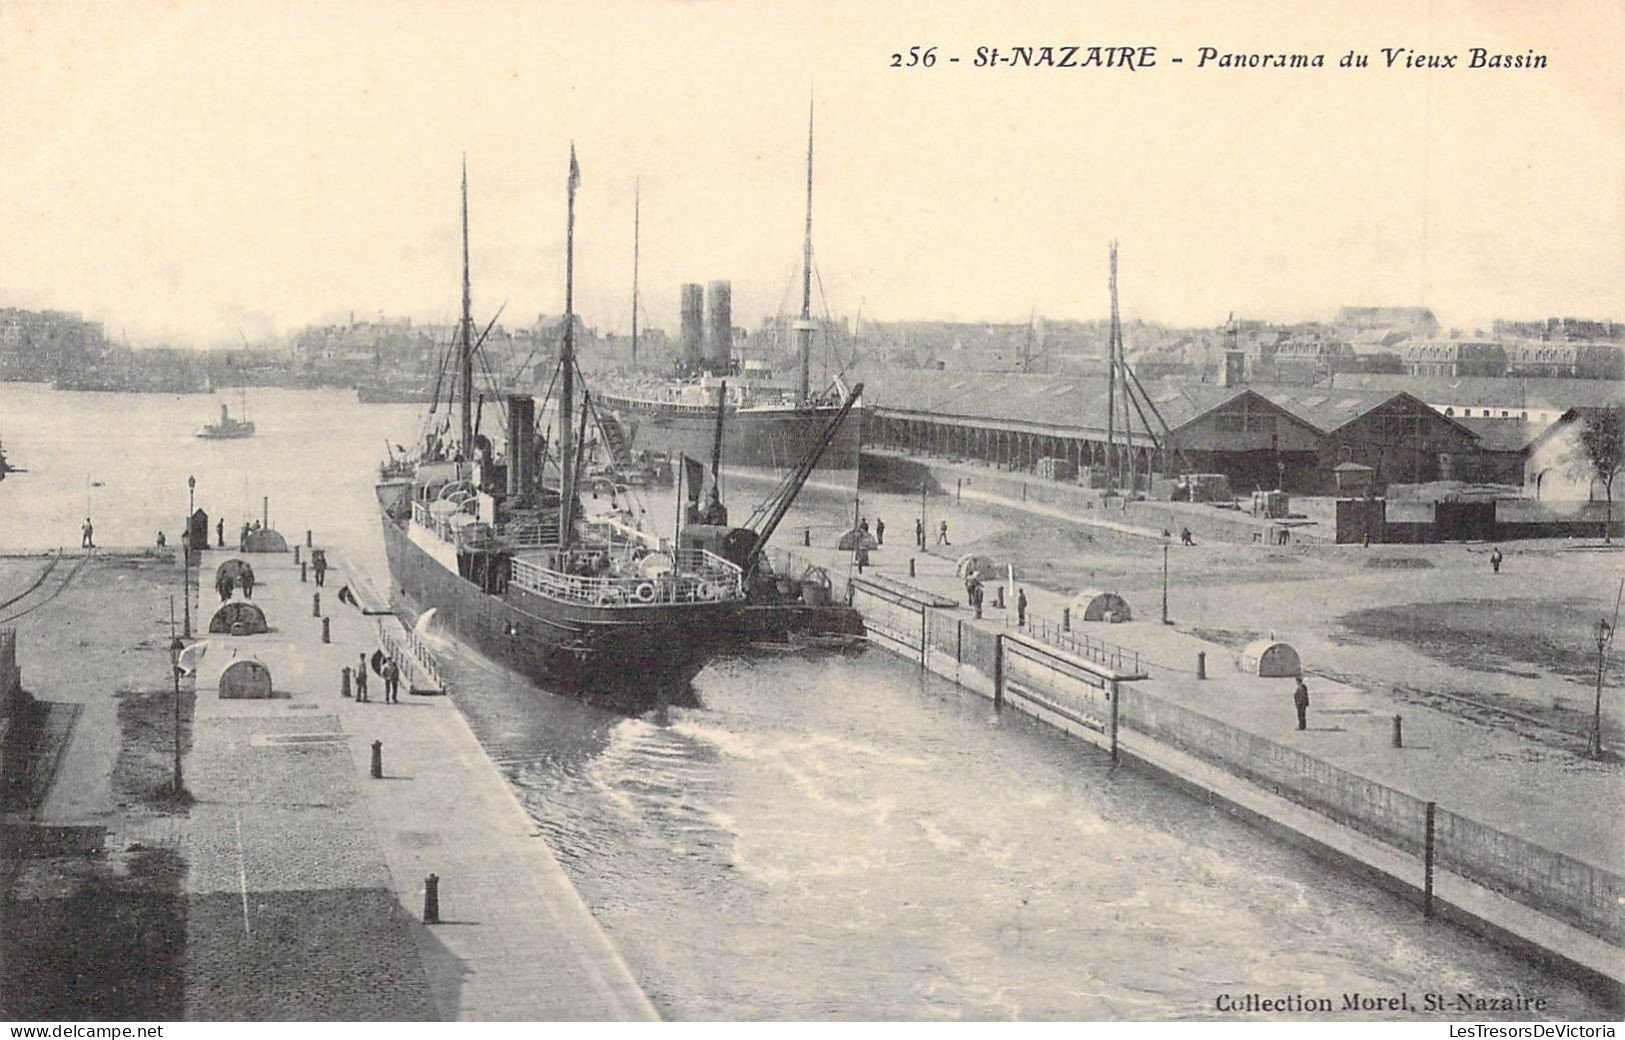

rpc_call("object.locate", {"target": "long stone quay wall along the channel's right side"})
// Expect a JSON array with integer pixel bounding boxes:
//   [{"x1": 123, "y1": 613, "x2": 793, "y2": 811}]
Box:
[{"x1": 837, "y1": 577, "x2": 1625, "y2": 986}]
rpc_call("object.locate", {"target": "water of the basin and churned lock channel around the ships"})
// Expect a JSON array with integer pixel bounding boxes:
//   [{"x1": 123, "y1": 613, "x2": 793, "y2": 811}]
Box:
[{"x1": 0, "y1": 384, "x2": 1610, "y2": 1019}]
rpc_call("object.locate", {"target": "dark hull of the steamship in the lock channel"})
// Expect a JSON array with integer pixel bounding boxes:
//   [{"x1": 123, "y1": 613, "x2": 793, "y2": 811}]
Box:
[{"x1": 384, "y1": 515, "x2": 739, "y2": 713}]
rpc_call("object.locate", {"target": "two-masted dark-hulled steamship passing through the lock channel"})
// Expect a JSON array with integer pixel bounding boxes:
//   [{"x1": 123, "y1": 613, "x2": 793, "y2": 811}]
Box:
[{"x1": 377, "y1": 148, "x2": 746, "y2": 710}]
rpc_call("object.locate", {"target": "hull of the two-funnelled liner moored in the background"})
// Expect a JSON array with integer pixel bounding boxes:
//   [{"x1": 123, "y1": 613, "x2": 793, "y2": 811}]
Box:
[{"x1": 598, "y1": 395, "x2": 863, "y2": 473}]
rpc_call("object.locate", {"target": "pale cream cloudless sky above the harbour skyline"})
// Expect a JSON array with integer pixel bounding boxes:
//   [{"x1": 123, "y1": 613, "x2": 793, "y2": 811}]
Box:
[{"x1": 0, "y1": 0, "x2": 1625, "y2": 346}]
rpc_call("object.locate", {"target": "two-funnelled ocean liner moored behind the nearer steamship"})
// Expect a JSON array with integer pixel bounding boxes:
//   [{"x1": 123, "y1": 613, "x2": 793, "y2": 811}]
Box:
[{"x1": 600, "y1": 111, "x2": 863, "y2": 481}]
